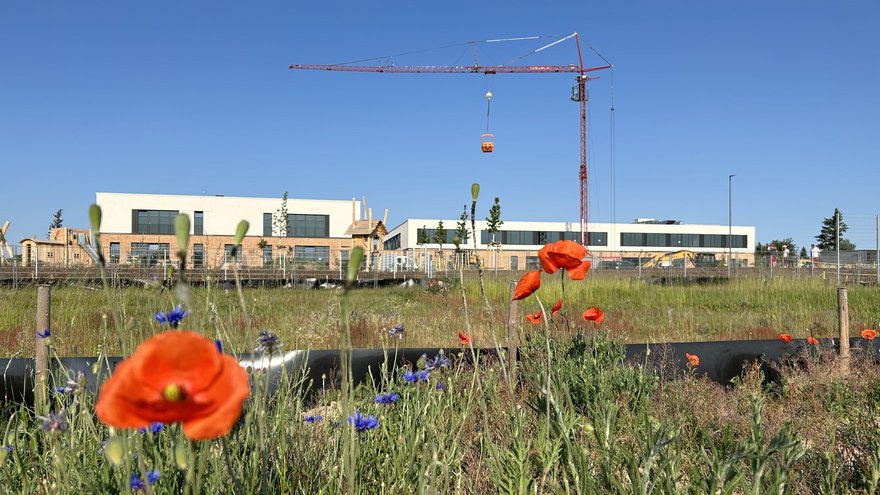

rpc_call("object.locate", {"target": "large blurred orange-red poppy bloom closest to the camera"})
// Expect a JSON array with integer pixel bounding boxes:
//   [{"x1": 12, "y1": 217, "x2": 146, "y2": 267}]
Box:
[{"x1": 95, "y1": 331, "x2": 250, "y2": 440}]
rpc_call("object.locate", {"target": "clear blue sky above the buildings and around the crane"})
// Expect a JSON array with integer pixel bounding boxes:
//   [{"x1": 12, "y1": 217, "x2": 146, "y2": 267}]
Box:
[{"x1": 0, "y1": 1, "x2": 880, "y2": 254}]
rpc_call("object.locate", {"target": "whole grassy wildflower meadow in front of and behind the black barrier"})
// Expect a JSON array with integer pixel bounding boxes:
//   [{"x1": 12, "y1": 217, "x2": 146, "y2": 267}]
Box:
[{"x1": 0, "y1": 274, "x2": 880, "y2": 494}]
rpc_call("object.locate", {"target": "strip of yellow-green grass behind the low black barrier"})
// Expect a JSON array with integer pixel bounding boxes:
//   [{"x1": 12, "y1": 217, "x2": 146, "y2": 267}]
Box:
[{"x1": 0, "y1": 277, "x2": 880, "y2": 356}]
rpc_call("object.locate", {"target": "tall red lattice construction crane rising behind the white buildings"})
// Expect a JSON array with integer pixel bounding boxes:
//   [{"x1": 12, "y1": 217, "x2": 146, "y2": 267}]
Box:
[{"x1": 288, "y1": 33, "x2": 612, "y2": 247}]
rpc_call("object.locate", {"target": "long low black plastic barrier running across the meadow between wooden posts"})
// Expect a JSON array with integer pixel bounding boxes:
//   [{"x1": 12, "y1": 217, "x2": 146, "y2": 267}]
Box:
[{"x1": 0, "y1": 337, "x2": 878, "y2": 405}]
